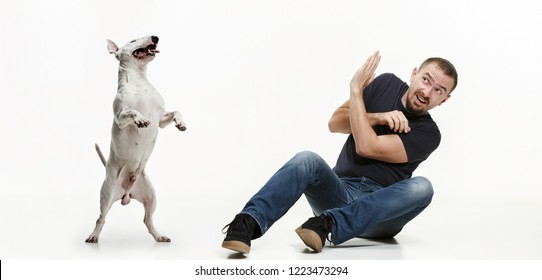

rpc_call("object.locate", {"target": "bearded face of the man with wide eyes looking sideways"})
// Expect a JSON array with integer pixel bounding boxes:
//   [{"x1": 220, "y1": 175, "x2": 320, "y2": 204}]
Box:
[{"x1": 403, "y1": 63, "x2": 454, "y2": 115}]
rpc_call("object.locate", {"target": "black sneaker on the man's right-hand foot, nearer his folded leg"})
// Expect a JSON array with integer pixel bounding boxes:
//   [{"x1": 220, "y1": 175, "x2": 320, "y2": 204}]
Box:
[{"x1": 295, "y1": 215, "x2": 334, "y2": 252}]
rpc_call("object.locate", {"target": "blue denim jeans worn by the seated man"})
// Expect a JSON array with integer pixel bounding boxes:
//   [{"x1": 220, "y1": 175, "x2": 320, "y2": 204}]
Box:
[{"x1": 241, "y1": 152, "x2": 433, "y2": 245}]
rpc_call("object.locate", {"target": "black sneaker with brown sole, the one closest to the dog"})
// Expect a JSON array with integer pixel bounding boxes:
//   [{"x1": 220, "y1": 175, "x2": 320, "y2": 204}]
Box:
[{"x1": 222, "y1": 214, "x2": 261, "y2": 254}]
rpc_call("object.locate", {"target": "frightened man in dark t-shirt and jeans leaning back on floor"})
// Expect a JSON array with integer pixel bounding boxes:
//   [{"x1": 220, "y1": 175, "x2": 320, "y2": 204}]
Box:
[{"x1": 222, "y1": 52, "x2": 457, "y2": 253}]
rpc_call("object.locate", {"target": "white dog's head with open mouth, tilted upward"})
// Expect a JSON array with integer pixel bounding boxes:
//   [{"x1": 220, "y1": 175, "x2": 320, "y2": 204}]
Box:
[{"x1": 107, "y1": 36, "x2": 159, "y2": 64}]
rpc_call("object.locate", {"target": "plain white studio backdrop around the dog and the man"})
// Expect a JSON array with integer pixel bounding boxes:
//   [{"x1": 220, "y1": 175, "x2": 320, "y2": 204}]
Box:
[{"x1": 0, "y1": 0, "x2": 542, "y2": 259}]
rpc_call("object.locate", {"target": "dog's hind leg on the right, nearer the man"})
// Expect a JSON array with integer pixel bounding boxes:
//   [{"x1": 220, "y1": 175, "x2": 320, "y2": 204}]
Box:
[{"x1": 131, "y1": 173, "x2": 171, "y2": 242}]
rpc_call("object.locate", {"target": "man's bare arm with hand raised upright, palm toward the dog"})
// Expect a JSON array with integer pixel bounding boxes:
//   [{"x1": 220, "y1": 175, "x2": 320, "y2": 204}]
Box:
[{"x1": 343, "y1": 52, "x2": 408, "y2": 163}]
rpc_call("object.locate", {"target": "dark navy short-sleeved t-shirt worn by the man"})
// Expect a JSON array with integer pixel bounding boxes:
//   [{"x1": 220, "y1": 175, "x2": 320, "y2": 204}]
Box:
[{"x1": 333, "y1": 73, "x2": 440, "y2": 186}]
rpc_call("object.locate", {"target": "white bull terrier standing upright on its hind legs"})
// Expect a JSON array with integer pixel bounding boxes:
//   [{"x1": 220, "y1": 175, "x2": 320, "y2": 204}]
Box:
[{"x1": 86, "y1": 36, "x2": 186, "y2": 243}]
